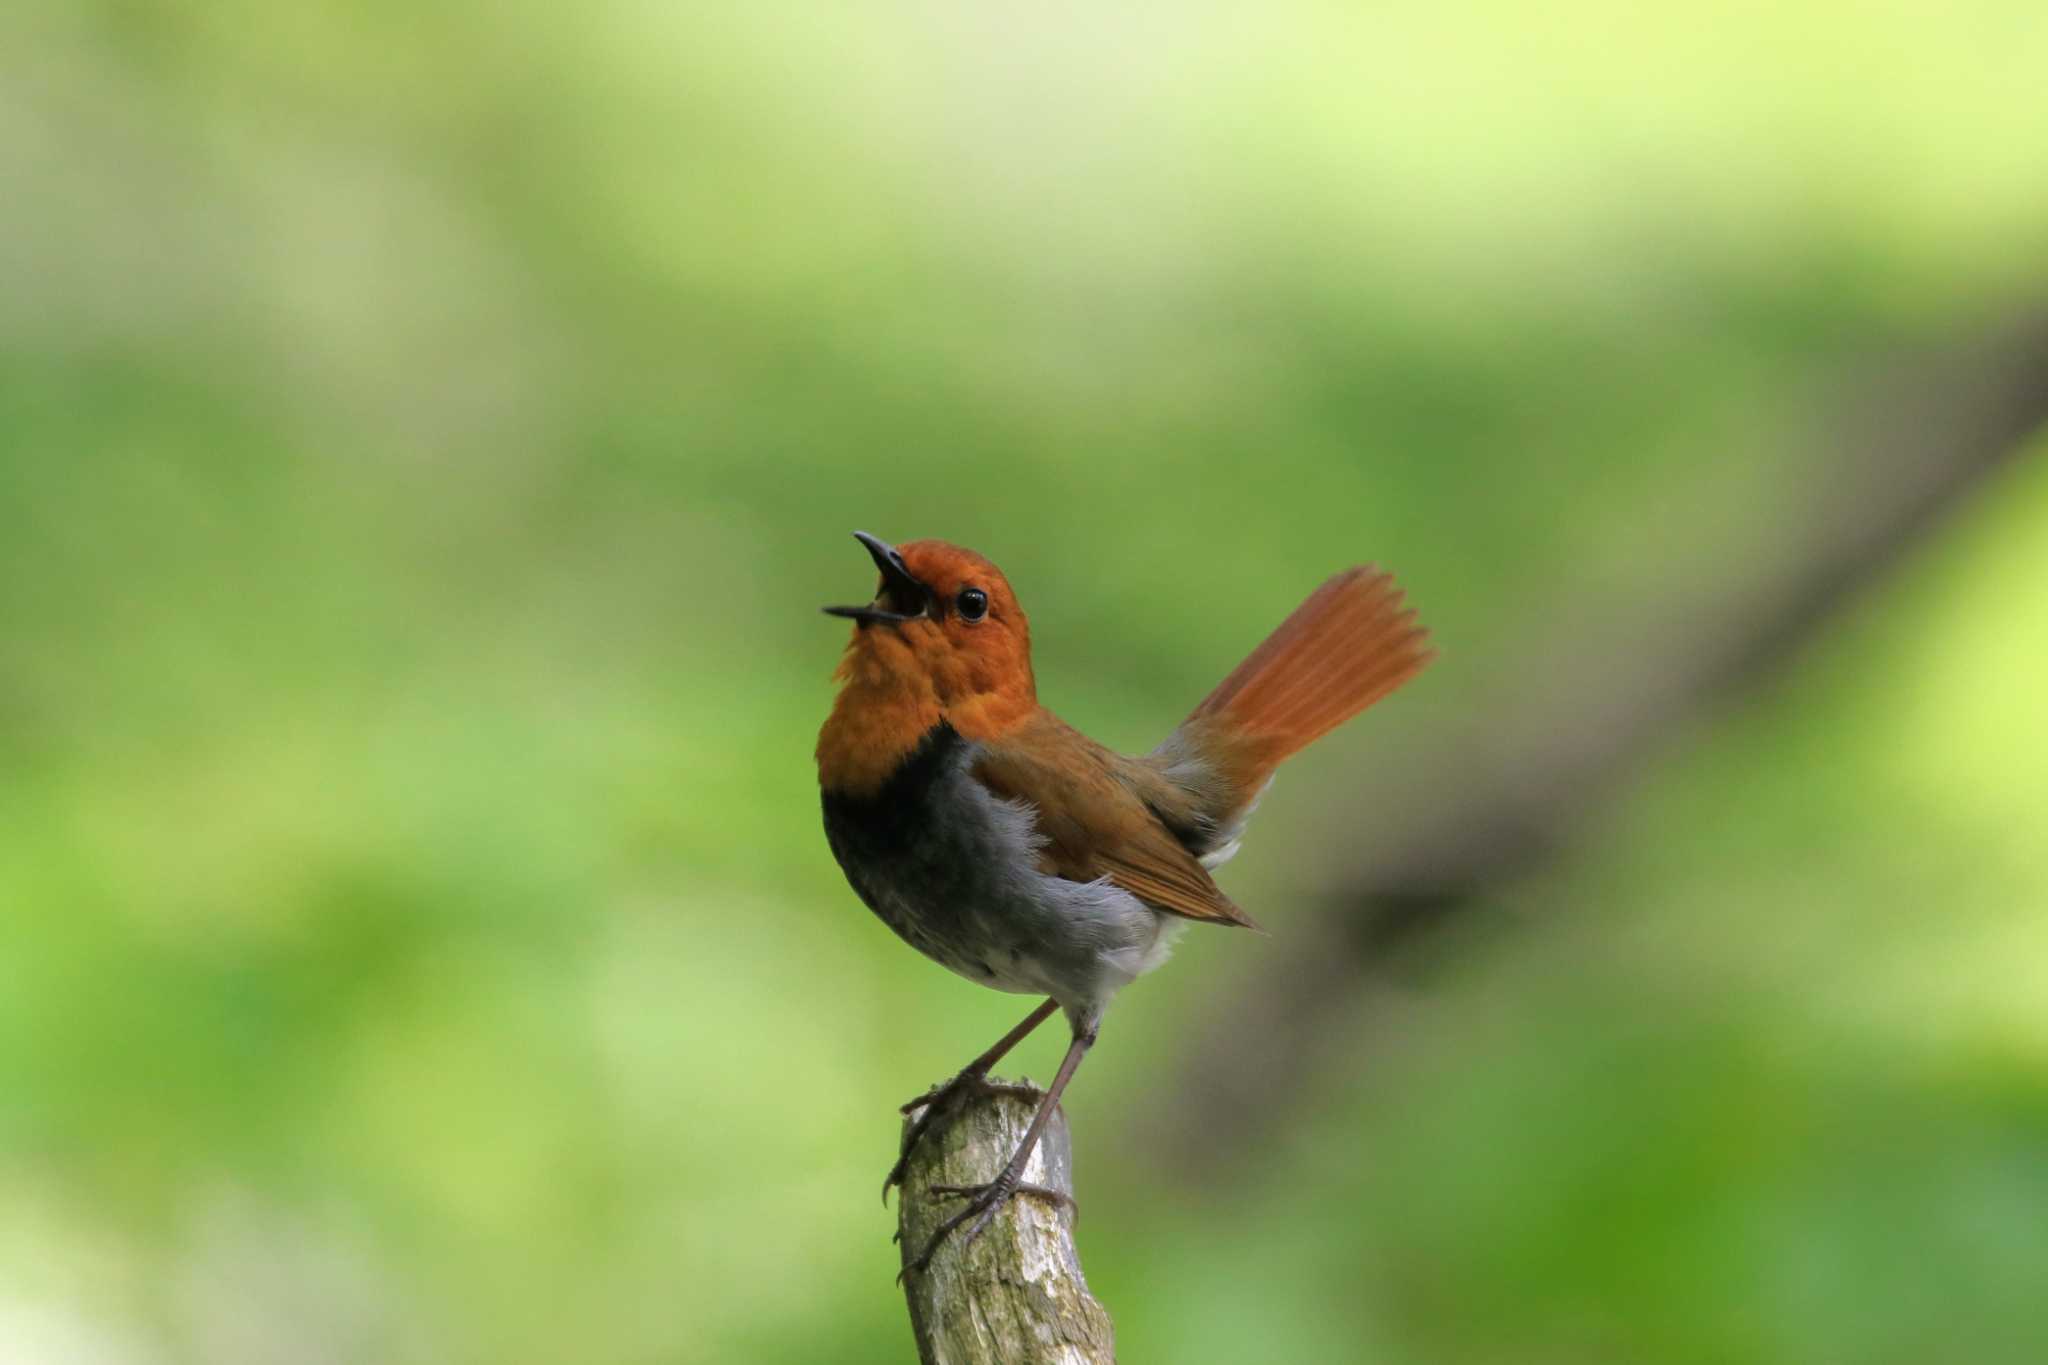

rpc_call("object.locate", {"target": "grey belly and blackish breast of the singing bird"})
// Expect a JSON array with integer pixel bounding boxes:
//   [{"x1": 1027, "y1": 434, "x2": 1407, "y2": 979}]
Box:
[{"x1": 825, "y1": 724, "x2": 1165, "y2": 1013}]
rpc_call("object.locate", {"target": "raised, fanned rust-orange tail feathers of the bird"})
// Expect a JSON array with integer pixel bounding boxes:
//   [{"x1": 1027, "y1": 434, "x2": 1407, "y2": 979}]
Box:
[{"x1": 1184, "y1": 565, "x2": 1436, "y2": 798}]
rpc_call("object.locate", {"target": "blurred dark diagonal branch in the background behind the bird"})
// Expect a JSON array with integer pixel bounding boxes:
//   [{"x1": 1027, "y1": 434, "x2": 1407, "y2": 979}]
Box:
[{"x1": 1147, "y1": 313, "x2": 2048, "y2": 1166}]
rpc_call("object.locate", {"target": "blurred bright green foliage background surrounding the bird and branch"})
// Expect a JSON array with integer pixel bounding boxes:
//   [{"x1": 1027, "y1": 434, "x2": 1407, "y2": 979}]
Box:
[{"x1": 0, "y1": 0, "x2": 2048, "y2": 1365}]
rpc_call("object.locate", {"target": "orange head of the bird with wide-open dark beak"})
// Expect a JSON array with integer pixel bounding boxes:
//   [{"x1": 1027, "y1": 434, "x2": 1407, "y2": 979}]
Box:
[{"x1": 825, "y1": 530, "x2": 1038, "y2": 739}]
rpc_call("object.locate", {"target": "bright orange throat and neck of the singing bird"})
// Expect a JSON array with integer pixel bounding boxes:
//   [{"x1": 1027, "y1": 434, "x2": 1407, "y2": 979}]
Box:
[{"x1": 817, "y1": 620, "x2": 1038, "y2": 796}]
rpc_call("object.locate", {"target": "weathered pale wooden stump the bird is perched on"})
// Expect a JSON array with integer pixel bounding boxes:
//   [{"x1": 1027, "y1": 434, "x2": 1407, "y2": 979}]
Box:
[{"x1": 897, "y1": 1083, "x2": 1116, "y2": 1365}]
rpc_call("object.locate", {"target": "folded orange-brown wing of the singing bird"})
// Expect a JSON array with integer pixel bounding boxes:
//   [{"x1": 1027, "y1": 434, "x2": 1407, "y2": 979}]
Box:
[{"x1": 975, "y1": 712, "x2": 1257, "y2": 929}]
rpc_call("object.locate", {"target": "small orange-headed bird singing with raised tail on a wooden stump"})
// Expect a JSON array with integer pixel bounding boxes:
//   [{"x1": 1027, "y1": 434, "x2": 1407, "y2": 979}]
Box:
[{"x1": 817, "y1": 532, "x2": 1434, "y2": 1273}]
